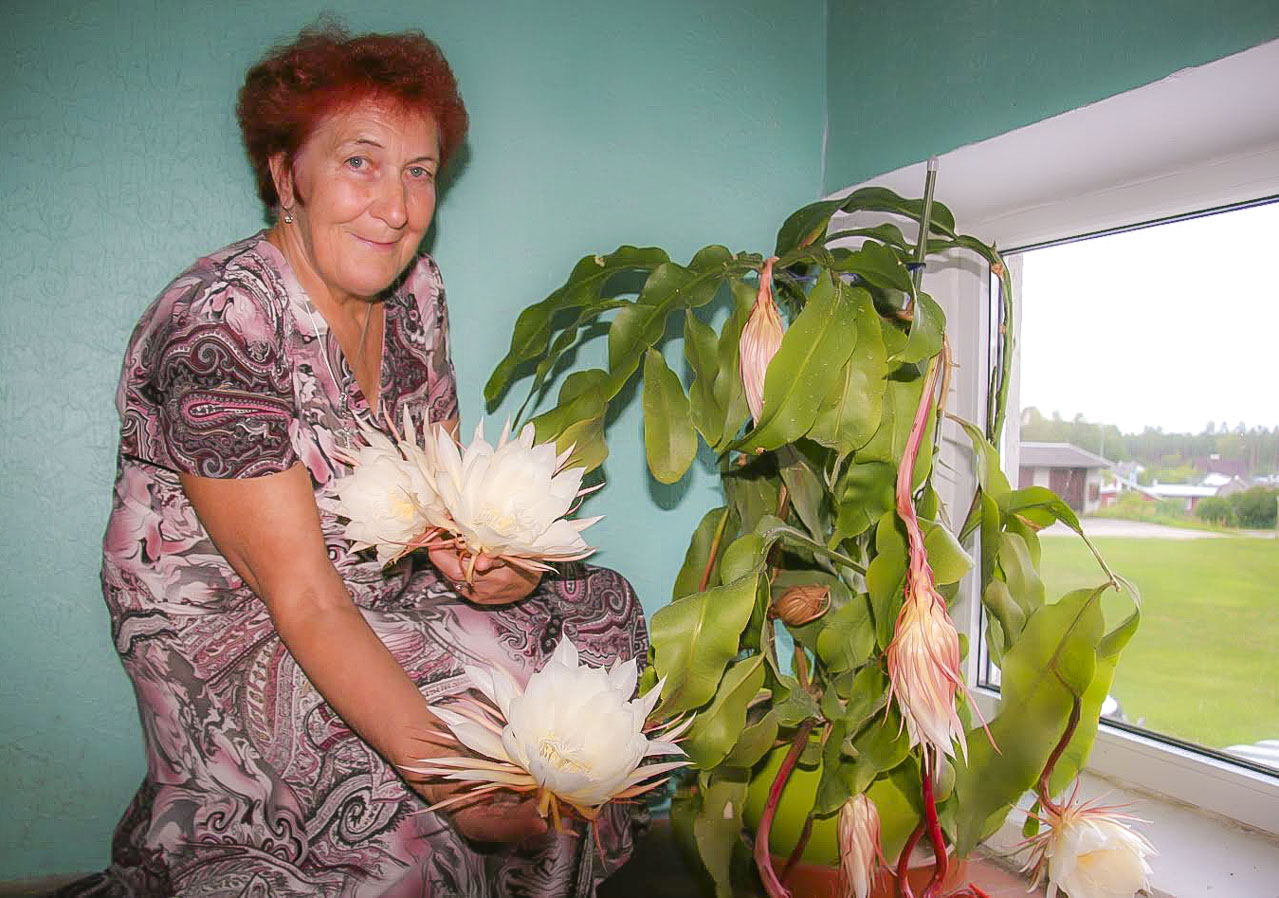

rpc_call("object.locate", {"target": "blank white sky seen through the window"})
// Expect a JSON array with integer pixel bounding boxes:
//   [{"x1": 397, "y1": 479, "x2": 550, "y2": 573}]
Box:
[{"x1": 1021, "y1": 202, "x2": 1279, "y2": 434}]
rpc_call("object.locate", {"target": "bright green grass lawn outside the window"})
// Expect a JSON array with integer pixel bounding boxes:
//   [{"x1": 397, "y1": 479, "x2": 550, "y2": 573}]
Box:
[{"x1": 1041, "y1": 536, "x2": 1279, "y2": 748}]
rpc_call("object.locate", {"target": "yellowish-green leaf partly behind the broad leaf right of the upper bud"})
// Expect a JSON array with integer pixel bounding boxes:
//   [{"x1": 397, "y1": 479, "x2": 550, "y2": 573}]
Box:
[{"x1": 808, "y1": 288, "x2": 889, "y2": 454}]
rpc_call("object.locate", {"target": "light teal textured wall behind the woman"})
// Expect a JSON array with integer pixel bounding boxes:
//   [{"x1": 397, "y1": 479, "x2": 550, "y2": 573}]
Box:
[{"x1": 0, "y1": 0, "x2": 825, "y2": 880}]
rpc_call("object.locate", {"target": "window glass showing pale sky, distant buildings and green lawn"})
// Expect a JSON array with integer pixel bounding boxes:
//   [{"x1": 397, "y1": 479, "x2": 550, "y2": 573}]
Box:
[{"x1": 991, "y1": 202, "x2": 1279, "y2": 773}]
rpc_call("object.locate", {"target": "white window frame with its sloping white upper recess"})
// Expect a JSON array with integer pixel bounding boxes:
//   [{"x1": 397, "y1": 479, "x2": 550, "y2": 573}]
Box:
[{"x1": 831, "y1": 35, "x2": 1279, "y2": 849}]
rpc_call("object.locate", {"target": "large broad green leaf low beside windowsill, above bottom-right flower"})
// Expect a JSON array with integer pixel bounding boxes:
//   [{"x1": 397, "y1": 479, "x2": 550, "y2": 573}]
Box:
[{"x1": 955, "y1": 590, "x2": 1102, "y2": 855}]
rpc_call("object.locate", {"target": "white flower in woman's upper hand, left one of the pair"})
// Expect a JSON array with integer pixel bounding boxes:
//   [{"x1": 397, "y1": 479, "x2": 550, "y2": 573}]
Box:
[{"x1": 329, "y1": 413, "x2": 440, "y2": 564}]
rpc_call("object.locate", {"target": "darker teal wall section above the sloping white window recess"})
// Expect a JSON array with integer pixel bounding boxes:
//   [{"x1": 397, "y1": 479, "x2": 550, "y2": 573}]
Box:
[{"x1": 825, "y1": 0, "x2": 1279, "y2": 192}]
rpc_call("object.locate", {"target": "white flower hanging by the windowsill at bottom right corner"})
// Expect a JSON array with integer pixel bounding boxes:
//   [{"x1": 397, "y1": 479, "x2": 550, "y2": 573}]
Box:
[{"x1": 1026, "y1": 801, "x2": 1156, "y2": 898}]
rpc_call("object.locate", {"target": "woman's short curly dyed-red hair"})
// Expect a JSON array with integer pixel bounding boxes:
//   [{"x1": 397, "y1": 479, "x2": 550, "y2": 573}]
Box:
[{"x1": 235, "y1": 23, "x2": 467, "y2": 209}]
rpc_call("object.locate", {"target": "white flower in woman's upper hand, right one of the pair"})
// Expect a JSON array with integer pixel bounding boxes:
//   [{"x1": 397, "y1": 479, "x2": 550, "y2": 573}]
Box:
[{"x1": 432, "y1": 423, "x2": 600, "y2": 578}]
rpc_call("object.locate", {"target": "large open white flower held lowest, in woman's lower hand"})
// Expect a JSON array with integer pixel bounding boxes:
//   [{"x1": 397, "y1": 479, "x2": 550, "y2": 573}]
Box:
[{"x1": 407, "y1": 638, "x2": 688, "y2": 820}]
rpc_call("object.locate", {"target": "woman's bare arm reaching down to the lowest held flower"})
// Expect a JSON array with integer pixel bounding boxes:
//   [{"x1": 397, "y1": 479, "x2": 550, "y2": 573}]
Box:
[{"x1": 182, "y1": 463, "x2": 546, "y2": 842}]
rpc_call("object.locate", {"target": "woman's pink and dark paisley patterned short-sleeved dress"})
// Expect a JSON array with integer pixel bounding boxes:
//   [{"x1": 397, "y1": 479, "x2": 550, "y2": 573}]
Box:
[{"x1": 65, "y1": 234, "x2": 647, "y2": 898}]
